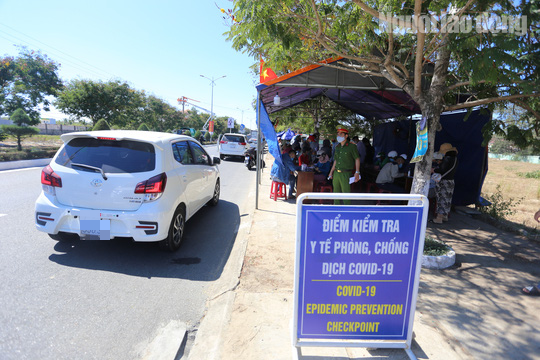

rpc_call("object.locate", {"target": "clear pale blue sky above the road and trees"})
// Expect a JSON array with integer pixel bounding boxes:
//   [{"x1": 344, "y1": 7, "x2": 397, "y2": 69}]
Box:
[{"x1": 0, "y1": 0, "x2": 258, "y2": 128}]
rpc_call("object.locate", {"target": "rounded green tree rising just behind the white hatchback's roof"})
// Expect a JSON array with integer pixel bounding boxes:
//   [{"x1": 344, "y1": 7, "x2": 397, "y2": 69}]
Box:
[{"x1": 55, "y1": 79, "x2": 144, "y2": 128}]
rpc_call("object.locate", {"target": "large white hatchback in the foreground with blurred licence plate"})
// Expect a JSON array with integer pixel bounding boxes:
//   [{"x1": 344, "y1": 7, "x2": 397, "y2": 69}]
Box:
[{"x1": 35, "y1": 130, "x2": 220, "y2": 251}]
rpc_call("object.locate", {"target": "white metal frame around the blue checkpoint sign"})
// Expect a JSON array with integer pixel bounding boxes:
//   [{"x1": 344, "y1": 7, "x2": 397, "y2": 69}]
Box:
[{"x1": 291, "y1": 193, "x2": 429, "y2": 360}]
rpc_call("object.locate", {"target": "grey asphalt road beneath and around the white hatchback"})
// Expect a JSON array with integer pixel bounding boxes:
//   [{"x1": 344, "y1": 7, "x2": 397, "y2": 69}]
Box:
[{"x1": 0, "y1": 146, "x2": 255, "y2": 360}]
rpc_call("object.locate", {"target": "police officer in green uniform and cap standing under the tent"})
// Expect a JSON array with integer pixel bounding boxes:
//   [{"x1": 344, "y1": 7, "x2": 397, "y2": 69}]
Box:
[{"x1": 328, "y1": 128, "x2": 360, "y2": 205}]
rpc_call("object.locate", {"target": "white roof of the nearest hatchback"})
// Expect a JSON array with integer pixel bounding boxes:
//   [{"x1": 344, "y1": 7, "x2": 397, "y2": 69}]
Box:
[{"x1": 60, "y1": 130, "x2": 193, "y2": 144}]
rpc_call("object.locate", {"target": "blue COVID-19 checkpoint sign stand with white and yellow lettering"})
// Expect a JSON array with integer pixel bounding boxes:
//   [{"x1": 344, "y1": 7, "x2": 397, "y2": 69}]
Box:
[{"x1": 292, "y1": 193, "x2": 428, "y2": 359}]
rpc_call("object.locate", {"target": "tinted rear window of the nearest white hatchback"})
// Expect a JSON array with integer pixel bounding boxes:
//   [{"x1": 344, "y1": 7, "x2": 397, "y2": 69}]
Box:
[{"x1": 56, "y1": 138, "x2": 156, "y2": 173}]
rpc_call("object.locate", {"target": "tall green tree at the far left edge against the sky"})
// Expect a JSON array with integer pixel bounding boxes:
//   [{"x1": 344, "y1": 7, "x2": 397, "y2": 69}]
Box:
[{"x1": 0, "y1": 48, "x2": 63, "y2": 125}]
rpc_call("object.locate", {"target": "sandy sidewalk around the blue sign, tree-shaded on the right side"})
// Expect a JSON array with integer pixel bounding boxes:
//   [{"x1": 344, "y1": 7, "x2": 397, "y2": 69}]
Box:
[{"x1": 189, "y1": 162, "x2": 540, "y2": 360}]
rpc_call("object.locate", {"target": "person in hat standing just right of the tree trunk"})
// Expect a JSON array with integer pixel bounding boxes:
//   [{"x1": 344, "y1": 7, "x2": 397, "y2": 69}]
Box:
[{"x1": 433, "y1": 143, "x2": 458, "y2": 224}]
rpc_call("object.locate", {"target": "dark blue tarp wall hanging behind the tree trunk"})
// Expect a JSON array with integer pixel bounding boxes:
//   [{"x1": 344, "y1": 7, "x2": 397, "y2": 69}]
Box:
[{"x1": 373, "y1": 110, "x2": 491, "y2": 205}]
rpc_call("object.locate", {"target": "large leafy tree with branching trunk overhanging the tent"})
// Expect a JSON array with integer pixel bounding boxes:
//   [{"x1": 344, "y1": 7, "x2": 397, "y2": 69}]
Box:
[{"x1": 228, "y1": 0, "x2": 540, "y2": 194}]
